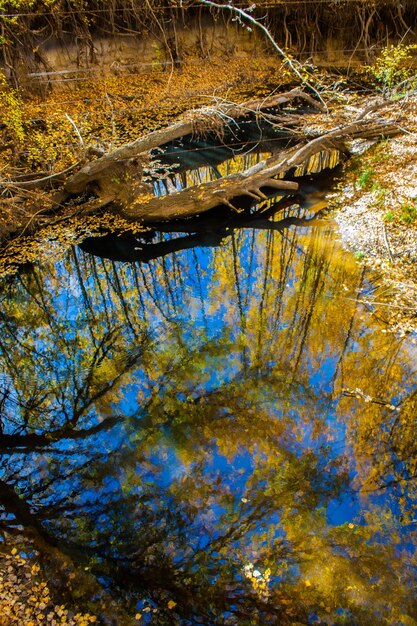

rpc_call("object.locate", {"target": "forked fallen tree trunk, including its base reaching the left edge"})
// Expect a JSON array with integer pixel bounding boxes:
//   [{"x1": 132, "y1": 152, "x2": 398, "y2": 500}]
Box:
[{"x1": 0, "y1": 89, "x2": 401, "y2": 249}]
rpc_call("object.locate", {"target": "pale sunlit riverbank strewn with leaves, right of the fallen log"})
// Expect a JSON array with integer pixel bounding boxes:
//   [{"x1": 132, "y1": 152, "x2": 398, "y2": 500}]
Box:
[{"x1": 330, "y1": 98, "x2": 417, "y2": 333}]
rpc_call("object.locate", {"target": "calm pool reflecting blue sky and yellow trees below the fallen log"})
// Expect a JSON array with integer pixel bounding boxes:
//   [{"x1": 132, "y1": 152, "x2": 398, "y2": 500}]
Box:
[{"x1": 0, "y1": 144, "x2": 417, "y2": 626}]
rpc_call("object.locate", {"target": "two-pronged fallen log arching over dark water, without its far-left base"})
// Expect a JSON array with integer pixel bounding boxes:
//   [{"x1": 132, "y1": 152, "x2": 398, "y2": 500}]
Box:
[{"x1": 59, "y1": 88, "x2": 399, "y2": 222}]
